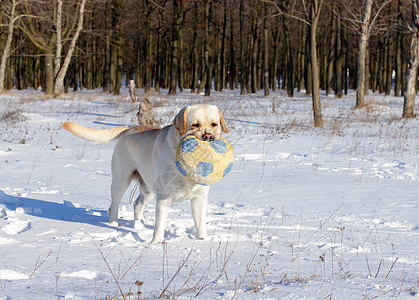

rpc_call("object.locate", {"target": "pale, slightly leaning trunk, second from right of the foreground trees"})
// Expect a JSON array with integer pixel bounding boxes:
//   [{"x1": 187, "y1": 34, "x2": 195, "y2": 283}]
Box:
[{"x1": 355, "y1": 0, "x2": 373, "y2": 108}]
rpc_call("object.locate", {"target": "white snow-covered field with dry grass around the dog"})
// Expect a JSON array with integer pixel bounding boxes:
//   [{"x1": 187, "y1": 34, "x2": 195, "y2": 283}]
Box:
[{"x1": 0, "y1": 90, "x2": 419, "y2": 299}]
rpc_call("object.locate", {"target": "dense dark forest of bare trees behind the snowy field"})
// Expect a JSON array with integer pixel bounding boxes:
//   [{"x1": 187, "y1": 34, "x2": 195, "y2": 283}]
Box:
[{"x1": 0, "y1": 0, "x2": 419, "y2": 127}]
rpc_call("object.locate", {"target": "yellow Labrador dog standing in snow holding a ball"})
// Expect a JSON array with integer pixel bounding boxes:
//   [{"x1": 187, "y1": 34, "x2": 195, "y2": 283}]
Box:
[{"x1": 62, "y1": 104, "x2": 228, "y2": 243}]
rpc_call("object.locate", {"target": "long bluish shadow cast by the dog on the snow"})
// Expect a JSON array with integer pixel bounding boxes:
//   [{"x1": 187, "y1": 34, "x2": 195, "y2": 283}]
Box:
[{"x1": 0, "y1": 190, "x2": 151, "y2": 243}]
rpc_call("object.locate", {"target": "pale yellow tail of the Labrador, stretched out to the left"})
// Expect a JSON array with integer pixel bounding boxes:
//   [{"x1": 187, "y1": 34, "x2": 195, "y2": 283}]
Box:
[{"x1": 62, "y1": 122, "x2": 129, "y2": 143}]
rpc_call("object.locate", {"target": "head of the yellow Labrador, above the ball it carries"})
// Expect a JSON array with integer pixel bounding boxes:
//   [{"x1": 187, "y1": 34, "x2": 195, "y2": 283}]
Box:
[{"x1": 173, "y1": 104, "x2": 228, "y2": 142}]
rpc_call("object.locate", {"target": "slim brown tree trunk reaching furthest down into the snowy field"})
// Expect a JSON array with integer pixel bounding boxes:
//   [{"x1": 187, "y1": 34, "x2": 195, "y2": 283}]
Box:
[{"x1": 310, "y1": 0, "x2": 323, "y2": 127}]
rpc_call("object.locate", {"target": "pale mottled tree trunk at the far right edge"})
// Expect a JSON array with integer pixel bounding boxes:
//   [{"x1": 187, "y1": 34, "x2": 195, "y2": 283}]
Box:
[{"x1": 403, "y1": 0, "x2": 419, "y2": 118}]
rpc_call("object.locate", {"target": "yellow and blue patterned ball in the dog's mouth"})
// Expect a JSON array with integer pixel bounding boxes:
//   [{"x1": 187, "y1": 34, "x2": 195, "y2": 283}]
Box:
[{"x1": 175, "y1": 135, "x2": 234, "y2": 185}]
